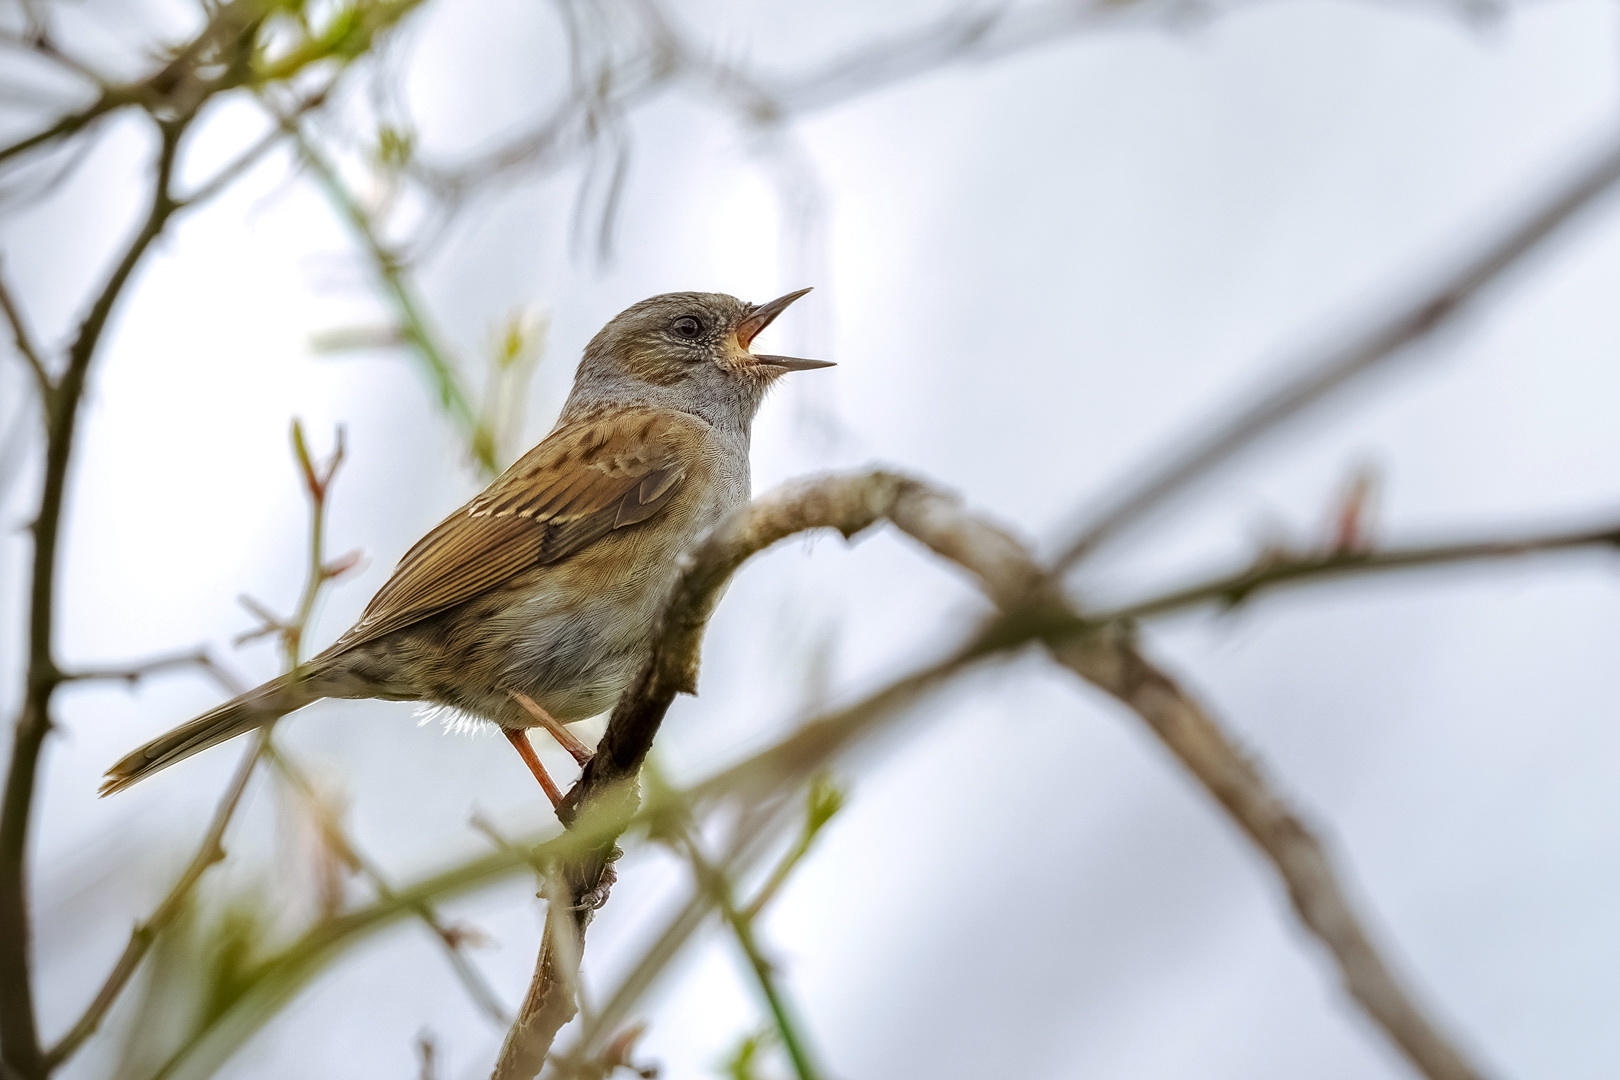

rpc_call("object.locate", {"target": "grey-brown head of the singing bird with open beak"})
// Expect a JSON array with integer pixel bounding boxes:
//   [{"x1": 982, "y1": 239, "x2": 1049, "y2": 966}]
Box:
[{"x1": 569, "y1": 288, "x2": 833, "y2": 433}]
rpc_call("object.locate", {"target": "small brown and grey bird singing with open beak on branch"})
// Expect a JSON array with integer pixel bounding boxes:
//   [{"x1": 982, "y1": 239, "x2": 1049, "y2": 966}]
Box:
[{"x1": 100, "y1": 288, "x2": 833, "y2": 806}]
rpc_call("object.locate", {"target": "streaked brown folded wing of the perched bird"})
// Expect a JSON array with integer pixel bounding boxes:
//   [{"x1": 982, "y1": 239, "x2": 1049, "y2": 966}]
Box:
[{"x1": 332, "y1": 411, "x2": 692, "y2": 651}]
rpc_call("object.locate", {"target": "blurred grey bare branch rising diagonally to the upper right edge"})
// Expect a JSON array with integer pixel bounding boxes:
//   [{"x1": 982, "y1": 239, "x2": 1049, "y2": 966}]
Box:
[{"x1": 1055, "y1": 127, "x2": 1620, "y2": 573}]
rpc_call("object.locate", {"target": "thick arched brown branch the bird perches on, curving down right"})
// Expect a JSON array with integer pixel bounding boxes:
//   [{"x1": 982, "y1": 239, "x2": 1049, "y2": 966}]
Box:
[{"x1": 494, "y1": 473, "x2": 1503, "y2": 1080}]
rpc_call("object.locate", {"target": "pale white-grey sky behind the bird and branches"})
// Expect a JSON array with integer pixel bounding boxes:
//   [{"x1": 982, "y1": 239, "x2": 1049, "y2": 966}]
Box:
[{"x1": 0, "y1": 0, "x2": 1620, "y2": 1080}]
